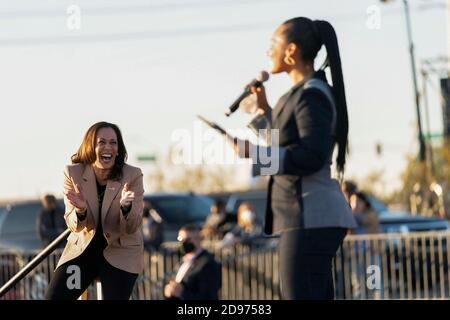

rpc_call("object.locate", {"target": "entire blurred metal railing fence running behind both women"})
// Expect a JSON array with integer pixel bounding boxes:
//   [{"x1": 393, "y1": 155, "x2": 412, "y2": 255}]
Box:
[{"x1": 0, "y1": 232, "x2": 450, "y2": 300}]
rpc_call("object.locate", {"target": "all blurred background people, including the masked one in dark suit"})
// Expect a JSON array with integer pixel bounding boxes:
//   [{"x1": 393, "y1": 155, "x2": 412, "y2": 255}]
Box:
[{"x1": 32, "y1": 181, "x2": 379, "y2": 300}]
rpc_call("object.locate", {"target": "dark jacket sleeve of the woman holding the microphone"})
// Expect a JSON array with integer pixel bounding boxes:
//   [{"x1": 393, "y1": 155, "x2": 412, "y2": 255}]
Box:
[{"x1": 279, "y1": 89, "x2": 333, "y2": 176}]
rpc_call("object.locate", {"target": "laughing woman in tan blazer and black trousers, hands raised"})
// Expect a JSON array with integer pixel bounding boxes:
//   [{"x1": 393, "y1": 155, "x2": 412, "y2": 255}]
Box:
[{"x1": 46, "y1": 122, "x2": 144, "y2": 300}]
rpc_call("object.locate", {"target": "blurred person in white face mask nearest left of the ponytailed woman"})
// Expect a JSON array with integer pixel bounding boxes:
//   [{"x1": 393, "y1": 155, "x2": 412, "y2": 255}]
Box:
[{"x1": 217, "y1": 202, "x2": 263, "y2": 249}]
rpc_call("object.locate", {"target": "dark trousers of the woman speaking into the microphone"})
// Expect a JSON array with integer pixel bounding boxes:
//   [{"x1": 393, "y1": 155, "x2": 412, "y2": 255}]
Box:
[{"x1": 278, "y1": 228, "x2": 347, "y2": 300}]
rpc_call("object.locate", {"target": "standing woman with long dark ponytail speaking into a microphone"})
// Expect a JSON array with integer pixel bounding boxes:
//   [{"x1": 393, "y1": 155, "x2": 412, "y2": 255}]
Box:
[{"x1": 232, "y1": 17, "x2": 356, "y2": 299}]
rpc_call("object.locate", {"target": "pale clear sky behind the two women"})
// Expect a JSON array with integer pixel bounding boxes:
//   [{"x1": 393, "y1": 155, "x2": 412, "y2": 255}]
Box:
[{"x1": 0, "y1": 0, "x2": 449, "y2": 199}]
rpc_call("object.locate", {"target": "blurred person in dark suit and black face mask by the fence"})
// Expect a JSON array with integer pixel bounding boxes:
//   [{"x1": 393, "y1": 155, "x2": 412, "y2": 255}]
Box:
[{"x1": 164, "y1": 224, "x2": 221, "y2": 300}]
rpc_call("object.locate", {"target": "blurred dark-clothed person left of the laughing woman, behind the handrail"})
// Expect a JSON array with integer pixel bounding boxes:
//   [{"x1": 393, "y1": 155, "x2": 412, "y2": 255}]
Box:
[{"x1": 37, "y1": 194, "x2": 67, "y2": 247}]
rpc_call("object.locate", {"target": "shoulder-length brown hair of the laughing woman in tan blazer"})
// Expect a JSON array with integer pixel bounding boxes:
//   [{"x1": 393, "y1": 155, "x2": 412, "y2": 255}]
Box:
[{"x1": 71, "y1": 121, "x2": 128, "y2": 180}]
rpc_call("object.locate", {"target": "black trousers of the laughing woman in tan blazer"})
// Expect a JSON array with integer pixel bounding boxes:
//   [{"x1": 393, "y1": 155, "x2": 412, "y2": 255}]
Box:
[{"x1": 45, "y1": 242, "x2": 138, "y2": 300}]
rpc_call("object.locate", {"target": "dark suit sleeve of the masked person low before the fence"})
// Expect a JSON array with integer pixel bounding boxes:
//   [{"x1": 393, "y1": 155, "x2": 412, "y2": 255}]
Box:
[{"x1": 181, "y1": 260, "x2": 221, "y2": 300}]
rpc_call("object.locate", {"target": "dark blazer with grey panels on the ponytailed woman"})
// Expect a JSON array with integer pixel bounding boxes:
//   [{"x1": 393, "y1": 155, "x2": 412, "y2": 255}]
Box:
[{"x1": 249, "y1": 71, "x2": 356, "y2": 234}]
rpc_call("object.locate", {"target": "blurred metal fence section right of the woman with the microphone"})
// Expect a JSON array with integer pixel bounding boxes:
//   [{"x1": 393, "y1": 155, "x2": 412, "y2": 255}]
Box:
[{"x1": 334, "y1": 231, "x2": 450, "y2": 299}]
